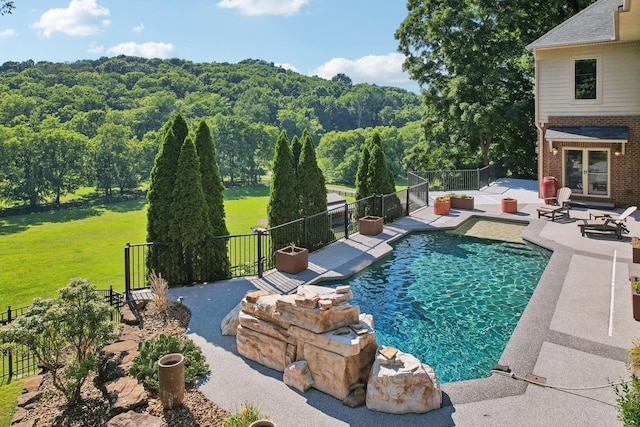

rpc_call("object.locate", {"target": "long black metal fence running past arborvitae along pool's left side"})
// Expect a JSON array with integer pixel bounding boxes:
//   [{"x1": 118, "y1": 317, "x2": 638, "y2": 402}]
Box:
[{"x1": 124, "y1": 174, "x2": 429, "y2": 298}]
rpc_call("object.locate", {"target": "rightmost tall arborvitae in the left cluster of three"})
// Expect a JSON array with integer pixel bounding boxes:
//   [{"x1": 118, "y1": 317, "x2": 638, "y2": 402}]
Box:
[{"x1": 195, "y1": 119, "x2": 229, "y2": 280}]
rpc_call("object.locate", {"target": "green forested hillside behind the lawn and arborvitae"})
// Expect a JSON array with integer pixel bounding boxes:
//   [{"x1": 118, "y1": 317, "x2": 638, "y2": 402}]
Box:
[{"x1": 0, "y1": 56, "x2": 422, "y2": 206}]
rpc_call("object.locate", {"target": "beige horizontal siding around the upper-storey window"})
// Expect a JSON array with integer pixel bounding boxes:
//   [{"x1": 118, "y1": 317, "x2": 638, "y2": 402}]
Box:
[{"x1": 536, "y1": 42, "x2": 640, "y2": 122}]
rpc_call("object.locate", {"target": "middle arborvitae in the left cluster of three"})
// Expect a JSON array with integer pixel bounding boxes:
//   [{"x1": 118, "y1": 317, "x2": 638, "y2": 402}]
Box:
[{"x1": 169, "y1": 136, "x2": 212, "y2": 283}]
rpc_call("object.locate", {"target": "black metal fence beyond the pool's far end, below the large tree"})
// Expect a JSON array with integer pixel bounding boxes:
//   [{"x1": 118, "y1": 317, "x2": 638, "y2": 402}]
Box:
[{"x1": 414, "y1": 163, "x2": 501, "y2": 191}]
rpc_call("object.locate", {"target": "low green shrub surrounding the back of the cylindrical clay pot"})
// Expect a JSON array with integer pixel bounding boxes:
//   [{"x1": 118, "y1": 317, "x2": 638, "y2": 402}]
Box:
[{"x1": 129, "y1": 334, "x2": 209, "y2": 391}]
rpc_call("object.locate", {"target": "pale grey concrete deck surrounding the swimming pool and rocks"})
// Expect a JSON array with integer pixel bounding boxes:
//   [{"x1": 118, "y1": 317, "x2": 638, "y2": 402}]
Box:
[{"x1": 170, "y1": 180, "x2": 640, "y2": 427}]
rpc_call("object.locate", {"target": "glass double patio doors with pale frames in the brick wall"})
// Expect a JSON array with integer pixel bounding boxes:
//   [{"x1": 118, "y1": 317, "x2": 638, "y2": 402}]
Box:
[{"x1": 563, "y1": 148, "x2": 609, "y2": 196}]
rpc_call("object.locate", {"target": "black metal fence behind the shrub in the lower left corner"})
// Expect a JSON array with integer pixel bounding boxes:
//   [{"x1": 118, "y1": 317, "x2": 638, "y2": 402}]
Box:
[{"x1": 0, "y1": 287, "x2": 125, "y2": 382}]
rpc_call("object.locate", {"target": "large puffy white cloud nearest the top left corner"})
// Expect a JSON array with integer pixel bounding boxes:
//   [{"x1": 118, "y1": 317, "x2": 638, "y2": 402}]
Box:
[{"x1": 31, "y1": 0, "x2": 110, "y2": 37}]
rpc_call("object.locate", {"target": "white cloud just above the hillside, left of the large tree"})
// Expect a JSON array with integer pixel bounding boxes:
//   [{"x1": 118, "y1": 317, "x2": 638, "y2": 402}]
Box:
[{"x1": 310, "y1": 53, "x2": 410, "y2": 86}]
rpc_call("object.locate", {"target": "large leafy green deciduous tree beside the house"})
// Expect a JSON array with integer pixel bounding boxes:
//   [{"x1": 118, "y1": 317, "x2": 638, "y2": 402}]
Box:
[{"x1": 395, "y1": 0, "x2": 590, "y2": 173}]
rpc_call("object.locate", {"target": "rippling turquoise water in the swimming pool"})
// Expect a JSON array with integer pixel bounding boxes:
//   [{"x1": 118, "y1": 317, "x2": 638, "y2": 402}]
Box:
[{"x1": 328, "y1": 227, "x2": 550, "y2": 383}]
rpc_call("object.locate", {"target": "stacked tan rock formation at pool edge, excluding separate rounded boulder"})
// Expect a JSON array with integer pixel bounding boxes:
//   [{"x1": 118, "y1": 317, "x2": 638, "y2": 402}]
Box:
[{"x1": 236, "y1": 285, "x2": 378, "y2": 400}]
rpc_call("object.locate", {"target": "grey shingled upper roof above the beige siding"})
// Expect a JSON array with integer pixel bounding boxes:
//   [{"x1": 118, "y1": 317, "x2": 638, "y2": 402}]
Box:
[{"x1": 527, "y1": 0, "x2": 623, "y2": 50}]
